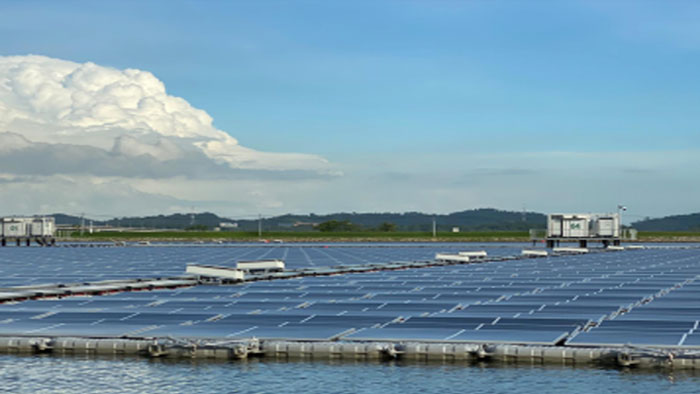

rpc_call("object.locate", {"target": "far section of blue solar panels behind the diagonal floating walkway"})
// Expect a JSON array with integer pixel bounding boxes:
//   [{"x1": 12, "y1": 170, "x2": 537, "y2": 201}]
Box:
[{"x1": 0, "y1": 244, "x2": 520, "y2": 287}]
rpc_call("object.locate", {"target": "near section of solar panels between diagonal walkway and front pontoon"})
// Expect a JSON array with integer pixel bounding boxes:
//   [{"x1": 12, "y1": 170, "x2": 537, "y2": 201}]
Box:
[{"x1": 0, "y1": 248, "x2": 700, "y2": 347}]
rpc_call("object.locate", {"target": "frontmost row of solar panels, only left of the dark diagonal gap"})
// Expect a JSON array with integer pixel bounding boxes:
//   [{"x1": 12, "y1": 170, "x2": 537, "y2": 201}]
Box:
[{"x1": 0, "y1": 308, "x2": 585, "y2": 342}]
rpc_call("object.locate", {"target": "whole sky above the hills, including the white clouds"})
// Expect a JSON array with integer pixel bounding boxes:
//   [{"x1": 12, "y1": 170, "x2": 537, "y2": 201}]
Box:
[{"x1": 0, "y1": 0, "x2": 700, "y2": 222}]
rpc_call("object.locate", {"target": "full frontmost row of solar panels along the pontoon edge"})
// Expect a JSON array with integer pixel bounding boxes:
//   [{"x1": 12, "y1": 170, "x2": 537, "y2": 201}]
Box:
[{"x1": 0, "y1": 308, "x2": 698, "y2": 346}]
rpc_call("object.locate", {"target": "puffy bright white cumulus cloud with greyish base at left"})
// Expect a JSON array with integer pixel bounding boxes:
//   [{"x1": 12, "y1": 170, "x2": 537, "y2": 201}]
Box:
[{"x1": 0, "y1": 56, "x2": 336, "y2": 177}]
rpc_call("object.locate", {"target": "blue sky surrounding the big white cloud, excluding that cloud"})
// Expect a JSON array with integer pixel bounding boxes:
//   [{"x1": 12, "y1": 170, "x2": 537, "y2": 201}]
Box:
[{"x1": 0, "y1": 1, "x2": 700, "y2": 220}]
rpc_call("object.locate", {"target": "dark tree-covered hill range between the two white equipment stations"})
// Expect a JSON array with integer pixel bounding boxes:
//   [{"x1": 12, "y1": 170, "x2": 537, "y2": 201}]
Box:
[{"x1": 53, "y1": 208, "x2": 547, "y2": 232}]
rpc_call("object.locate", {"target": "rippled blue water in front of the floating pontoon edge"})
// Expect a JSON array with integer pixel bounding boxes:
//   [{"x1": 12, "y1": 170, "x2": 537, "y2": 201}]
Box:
[{"x1": 0, "y1": 356, "x2": 700, "y2": 394}]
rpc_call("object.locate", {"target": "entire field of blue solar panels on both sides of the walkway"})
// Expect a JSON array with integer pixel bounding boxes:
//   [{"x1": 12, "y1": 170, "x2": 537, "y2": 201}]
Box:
[{"x1": 0, "y1": 244, "x2": 700, "y2": 349}]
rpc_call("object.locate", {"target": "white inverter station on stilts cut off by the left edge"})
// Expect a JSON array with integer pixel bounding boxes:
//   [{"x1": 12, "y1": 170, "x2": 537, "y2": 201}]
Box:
[{"x1": 0, "y1": 216, "x2": 56, "y2": 246}]
